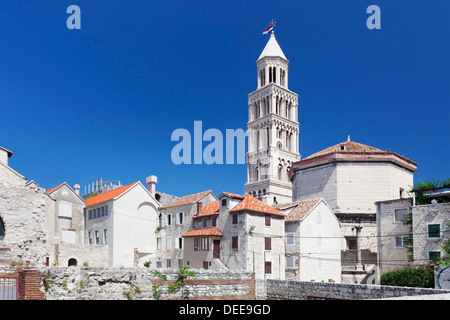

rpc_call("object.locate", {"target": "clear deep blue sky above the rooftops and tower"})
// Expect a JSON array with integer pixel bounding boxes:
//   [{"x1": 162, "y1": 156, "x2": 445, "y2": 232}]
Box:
[{"x1": 0, "y1": 0, "x2": 450, "y2": 196}]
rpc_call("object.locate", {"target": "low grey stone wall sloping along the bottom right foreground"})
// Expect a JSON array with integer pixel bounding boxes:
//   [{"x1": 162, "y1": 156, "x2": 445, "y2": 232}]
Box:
[{"x1": 262, "y1": 280, "x2": 450, "y2": 300}]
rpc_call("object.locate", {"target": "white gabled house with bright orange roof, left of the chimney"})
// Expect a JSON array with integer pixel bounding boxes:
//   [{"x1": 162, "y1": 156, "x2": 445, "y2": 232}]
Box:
[{"x1": 85, "y1": 181, "x2": 160, "y2": 267}]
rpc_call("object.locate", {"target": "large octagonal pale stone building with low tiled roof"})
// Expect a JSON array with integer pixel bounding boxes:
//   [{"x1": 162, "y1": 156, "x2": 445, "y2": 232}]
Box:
[{"x1": 290, "y1": 137, "x2": 417, "y2": 283}]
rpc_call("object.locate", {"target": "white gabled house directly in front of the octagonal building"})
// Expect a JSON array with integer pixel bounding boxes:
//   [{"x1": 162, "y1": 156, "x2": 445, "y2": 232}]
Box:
[{"x1": 273, "y1": 198, "x2": 344, "y2": 283}]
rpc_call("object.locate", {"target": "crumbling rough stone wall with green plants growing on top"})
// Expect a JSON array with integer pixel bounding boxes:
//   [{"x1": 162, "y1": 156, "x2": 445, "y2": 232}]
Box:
[{"x1": 40, "y1": 267, "x2": 255, "y2": 300}]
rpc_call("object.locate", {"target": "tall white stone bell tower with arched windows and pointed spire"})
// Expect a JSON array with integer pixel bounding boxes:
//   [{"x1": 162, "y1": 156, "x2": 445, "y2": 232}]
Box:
[{"x1": 244, "y1": 31, "x2": 301, "y2": 205}]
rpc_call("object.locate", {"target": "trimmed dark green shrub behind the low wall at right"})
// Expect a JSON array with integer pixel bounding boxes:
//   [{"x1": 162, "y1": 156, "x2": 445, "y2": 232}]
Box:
[{"x1": 381, "y1": 267, "x2": 434, "y2": 288}]
